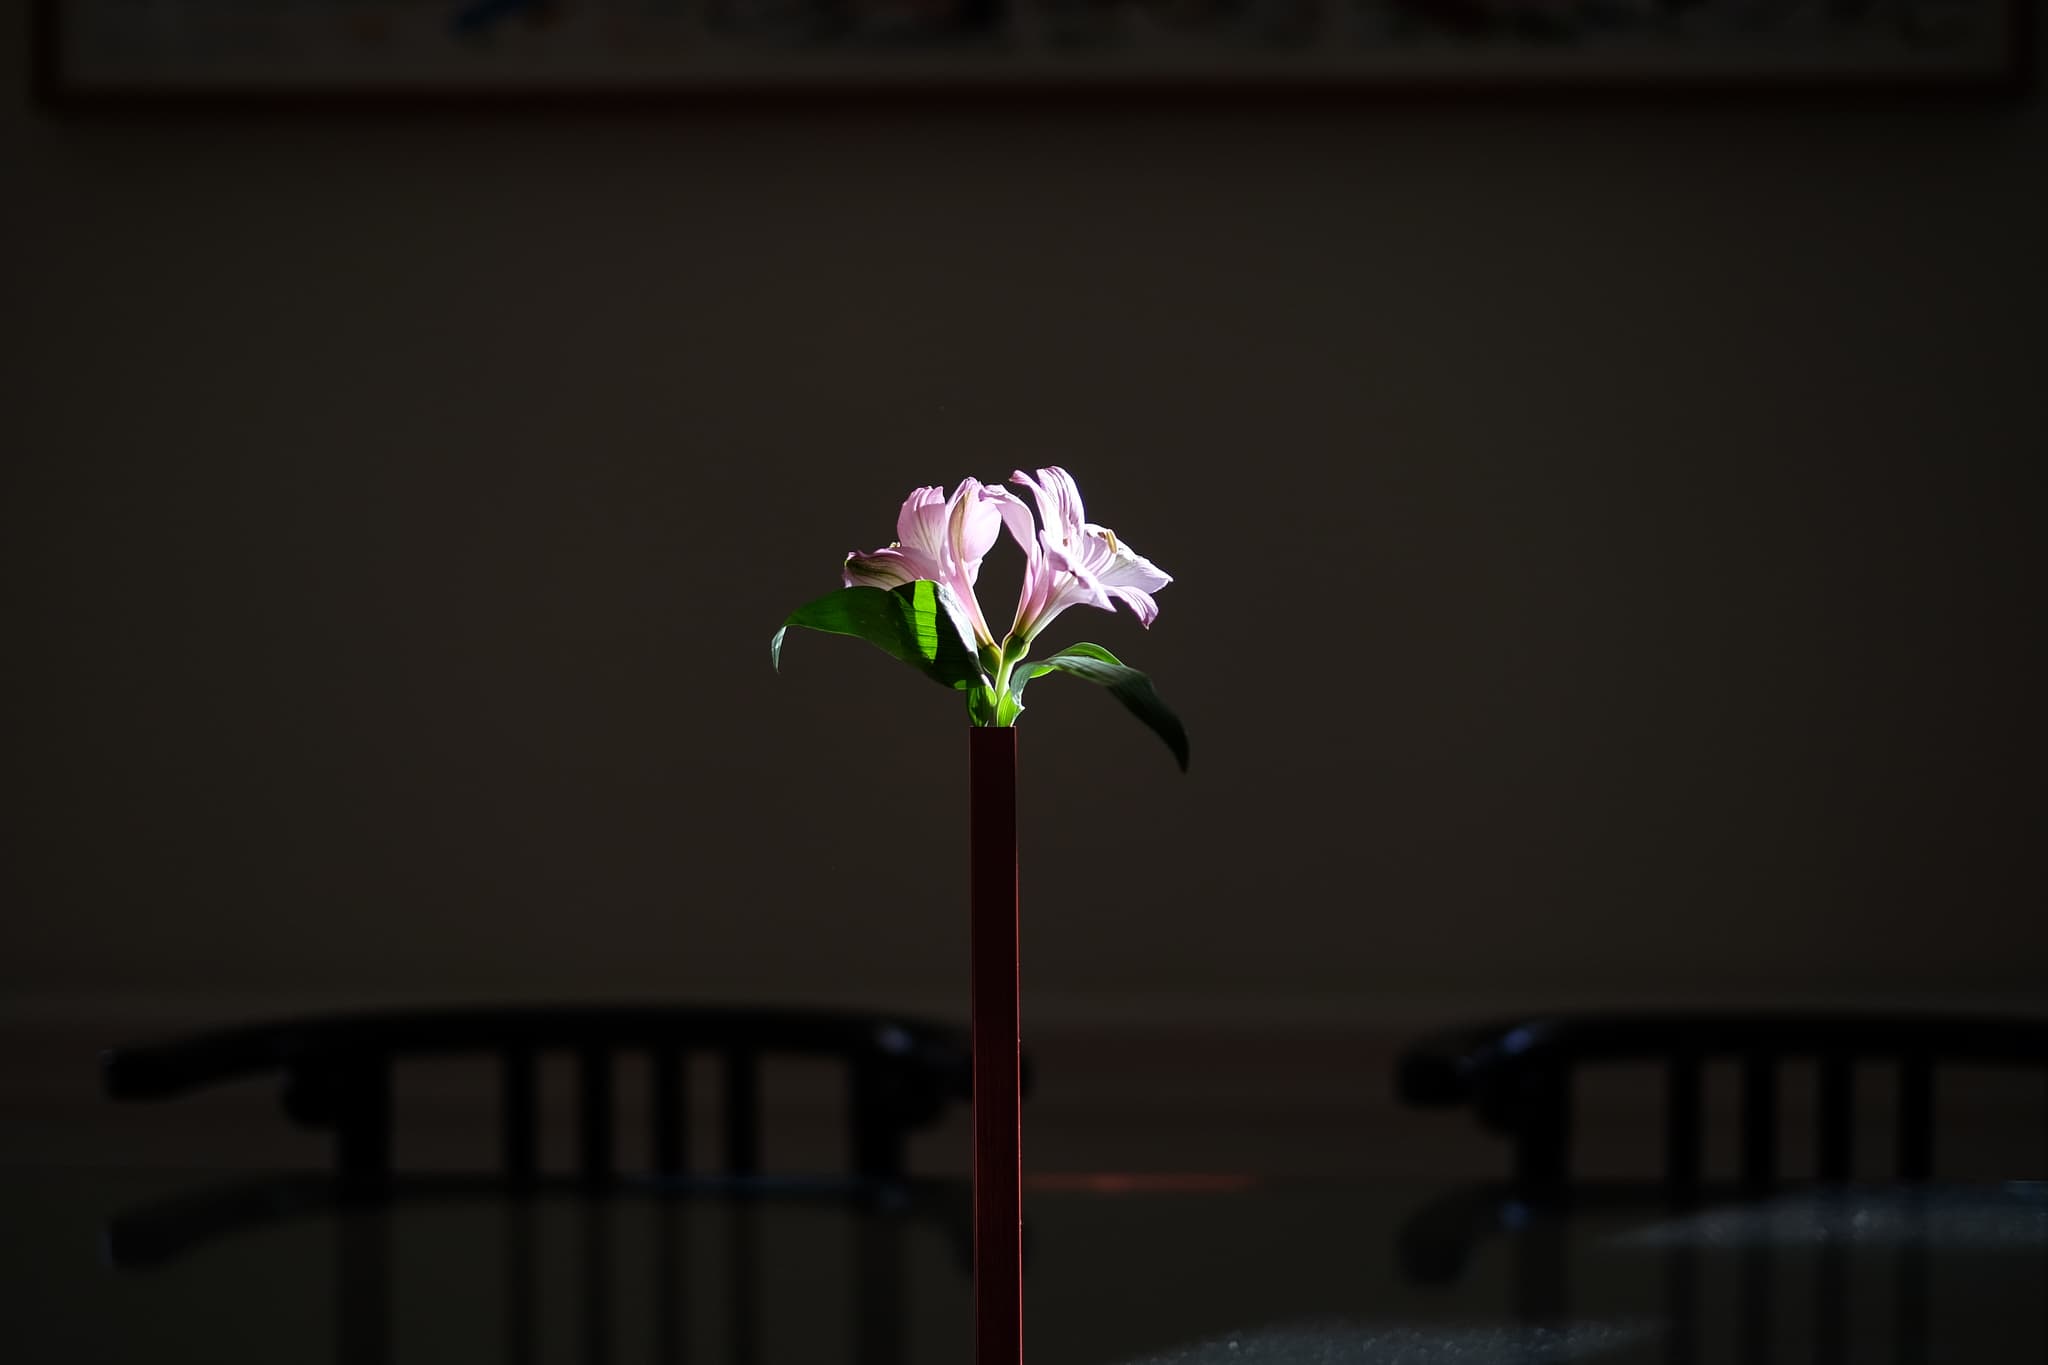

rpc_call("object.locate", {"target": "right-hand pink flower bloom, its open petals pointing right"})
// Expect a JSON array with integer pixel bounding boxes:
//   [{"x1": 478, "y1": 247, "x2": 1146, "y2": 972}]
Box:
[{"x1": 991, "y1": 465, "x2": 1174, "y2": 641}]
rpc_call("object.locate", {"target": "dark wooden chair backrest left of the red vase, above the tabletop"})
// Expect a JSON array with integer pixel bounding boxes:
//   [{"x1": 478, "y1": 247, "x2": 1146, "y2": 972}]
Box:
[{"x1": 102, "y1": 1005, "x2": 973, "y2": 1185}]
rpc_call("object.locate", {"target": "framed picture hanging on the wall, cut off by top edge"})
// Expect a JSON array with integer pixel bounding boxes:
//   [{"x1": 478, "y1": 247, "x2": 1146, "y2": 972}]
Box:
[{"x1": 37, "y1": 0, "x2": 2034, "y2": 104}]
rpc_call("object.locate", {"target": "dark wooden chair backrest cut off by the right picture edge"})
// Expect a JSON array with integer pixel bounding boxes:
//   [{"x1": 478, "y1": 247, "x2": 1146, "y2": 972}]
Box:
[{"x1": 1397, "y1": 1013, "x2": 2048, "y2": 1193}]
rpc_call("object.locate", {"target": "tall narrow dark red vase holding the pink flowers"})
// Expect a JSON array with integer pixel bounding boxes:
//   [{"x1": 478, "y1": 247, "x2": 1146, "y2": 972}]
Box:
[{"x1": 967, "y1": 726, "x2": 1024, "y2": 1365}]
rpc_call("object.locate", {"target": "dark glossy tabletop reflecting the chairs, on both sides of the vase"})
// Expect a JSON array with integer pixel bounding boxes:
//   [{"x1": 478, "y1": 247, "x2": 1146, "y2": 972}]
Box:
[{"x1": 0, "y1": 1169, "x2": 2048, "y2": 1365}]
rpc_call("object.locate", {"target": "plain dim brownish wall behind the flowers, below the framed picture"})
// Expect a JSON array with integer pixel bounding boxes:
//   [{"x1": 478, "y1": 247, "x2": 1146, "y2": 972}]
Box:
[{"x1": 0, "y1": 13, "x2": 2048, "y2": 1047}]
